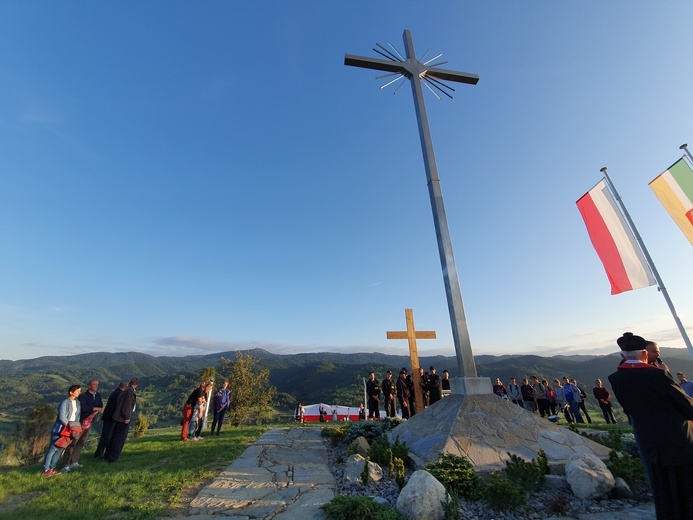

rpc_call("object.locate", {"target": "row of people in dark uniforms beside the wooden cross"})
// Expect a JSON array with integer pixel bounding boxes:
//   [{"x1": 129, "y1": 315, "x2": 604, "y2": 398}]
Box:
[{"x1": 364, "y1": 366, "x2": 450, "y2": 420}]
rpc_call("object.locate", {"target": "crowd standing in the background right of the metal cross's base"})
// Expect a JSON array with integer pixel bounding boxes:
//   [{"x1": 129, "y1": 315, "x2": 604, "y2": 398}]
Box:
[{"x1": 493, "y1": 376, "x2": 616, "y2": 424}]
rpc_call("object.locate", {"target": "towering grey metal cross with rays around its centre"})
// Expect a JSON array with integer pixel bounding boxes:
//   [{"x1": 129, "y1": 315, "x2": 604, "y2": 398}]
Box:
[{"x1": 344, "y1": 30, "x2": 479, "y2": 377}]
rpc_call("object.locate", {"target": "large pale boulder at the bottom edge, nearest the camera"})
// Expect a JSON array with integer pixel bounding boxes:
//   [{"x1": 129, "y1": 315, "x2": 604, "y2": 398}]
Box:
[{"x1": 395, "y1": 470, "x2": 447, "y2": 520}]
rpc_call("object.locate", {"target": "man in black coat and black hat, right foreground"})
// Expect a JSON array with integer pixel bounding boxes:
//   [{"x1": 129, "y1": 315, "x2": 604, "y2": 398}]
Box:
[{"x1": 609, "y1": 332, "x2": 693, "y2": 520}]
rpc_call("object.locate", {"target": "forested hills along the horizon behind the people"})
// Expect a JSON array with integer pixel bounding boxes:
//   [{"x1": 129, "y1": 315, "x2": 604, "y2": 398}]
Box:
[{"x1": 0, "y1": 349, "x2": 693, "y2": 435}]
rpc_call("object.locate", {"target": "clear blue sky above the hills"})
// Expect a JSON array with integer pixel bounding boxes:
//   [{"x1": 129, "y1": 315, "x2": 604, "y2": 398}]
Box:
[{"x1": 0, "y1": 0, "x2": 693, "y2": 359}]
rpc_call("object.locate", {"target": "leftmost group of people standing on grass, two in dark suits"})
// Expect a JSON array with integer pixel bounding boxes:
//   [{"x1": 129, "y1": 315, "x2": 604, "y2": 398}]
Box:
[{"x1": 43, "y1": 378, "x2": 140, "y2": 477}]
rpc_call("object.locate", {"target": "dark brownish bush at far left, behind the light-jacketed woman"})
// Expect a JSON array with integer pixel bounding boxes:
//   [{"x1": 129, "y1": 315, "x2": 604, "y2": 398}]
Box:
[{"x1": 12, "y1": 404, "x2": 55, "y2": 464}]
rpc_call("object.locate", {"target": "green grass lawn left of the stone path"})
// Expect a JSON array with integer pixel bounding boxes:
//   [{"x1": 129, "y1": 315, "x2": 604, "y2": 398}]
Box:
[{"x1": 0, "y1": 426, "x2": 268, "y2": 520}]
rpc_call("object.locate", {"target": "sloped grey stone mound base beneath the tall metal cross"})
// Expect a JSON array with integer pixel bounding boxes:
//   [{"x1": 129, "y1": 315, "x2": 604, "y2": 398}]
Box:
[{"x1": 388, "y1": 394, "x2": 610, "y2": 473}]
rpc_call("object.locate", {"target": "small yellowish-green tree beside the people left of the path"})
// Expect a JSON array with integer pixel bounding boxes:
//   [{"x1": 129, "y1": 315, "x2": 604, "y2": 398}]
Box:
[{"x1": 220, "y1": 352, "x2": 277, "y2": 426}]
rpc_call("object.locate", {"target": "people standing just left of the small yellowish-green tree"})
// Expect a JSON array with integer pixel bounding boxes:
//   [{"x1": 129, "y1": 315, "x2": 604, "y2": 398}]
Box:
[{"x1": 181, "y1": 380, "x2": 231, "y2": 442}]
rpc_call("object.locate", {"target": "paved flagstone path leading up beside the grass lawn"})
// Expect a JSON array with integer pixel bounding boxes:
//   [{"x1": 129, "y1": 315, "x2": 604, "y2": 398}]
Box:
[{"x1": 189, "y1": 428, "x2": 335, "y2": 520}]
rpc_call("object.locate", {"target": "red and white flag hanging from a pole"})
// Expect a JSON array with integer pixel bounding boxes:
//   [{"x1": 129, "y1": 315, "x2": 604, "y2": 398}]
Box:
[{"x1": 577, "y1": 180, "x2": 656, "y2": 294}]
